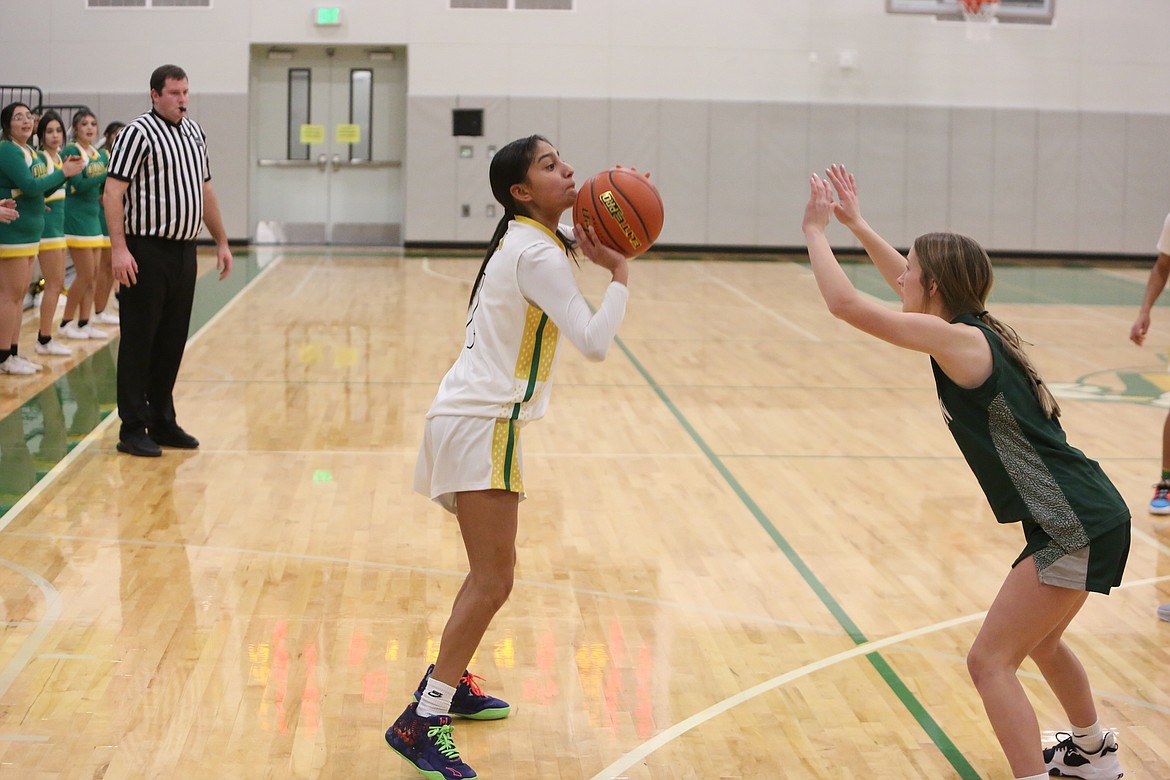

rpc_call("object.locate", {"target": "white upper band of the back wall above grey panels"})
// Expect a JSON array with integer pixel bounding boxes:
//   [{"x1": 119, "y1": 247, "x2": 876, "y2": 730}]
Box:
[{"x1": 9, "y1": 0, "x2": 1170, "y2": 113}]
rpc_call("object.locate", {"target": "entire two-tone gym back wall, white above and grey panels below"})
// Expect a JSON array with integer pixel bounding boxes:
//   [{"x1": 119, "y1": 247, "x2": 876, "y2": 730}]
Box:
[{"x1": 0, "y1": 0, "x2": 1170, "y2": 254}]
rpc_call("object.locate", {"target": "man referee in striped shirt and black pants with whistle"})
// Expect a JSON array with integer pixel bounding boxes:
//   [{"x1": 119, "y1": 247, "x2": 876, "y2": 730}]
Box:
[{"x1": 102, "y1": 65, "x2": 232, "y2": 457}]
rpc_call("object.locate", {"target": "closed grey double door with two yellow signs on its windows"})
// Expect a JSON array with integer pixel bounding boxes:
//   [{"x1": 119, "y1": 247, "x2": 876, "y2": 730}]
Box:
[{"x1": 250, "y1": 46, "x2": 406, "y2": 246}]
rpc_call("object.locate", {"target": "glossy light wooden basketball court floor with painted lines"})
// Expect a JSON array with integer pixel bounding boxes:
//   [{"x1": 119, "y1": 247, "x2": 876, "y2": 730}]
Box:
[{"x1": 0, "y1": 249, "x2": 1170, "y2": 780}]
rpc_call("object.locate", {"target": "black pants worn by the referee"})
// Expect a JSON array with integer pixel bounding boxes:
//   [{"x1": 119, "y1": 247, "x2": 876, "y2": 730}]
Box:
[{"x1": 118, "y1": 235, "x2": 195, "y2": 439}]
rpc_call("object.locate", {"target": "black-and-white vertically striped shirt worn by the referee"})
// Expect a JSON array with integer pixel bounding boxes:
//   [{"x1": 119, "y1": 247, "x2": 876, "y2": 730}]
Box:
[{"x1": 108, "y1": 110, "x2": 212, "y2": 241}]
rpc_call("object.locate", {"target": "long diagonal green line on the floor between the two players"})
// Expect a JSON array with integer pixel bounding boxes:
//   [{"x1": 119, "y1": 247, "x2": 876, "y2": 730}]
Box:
[{"x1": 614, "y1": 337, "x2": 979, "y2": 780}]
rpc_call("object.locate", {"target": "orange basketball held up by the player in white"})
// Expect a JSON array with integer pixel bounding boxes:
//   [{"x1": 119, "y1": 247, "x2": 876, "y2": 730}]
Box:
[{"x1": 573, "y1": 168, "x2": 663, "y2": 257}]
